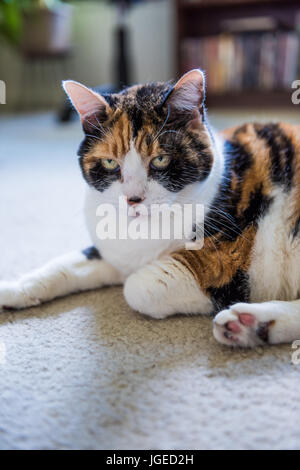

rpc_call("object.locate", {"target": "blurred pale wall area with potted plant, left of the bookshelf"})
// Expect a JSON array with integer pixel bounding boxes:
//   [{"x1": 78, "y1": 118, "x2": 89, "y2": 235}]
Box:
[{"x1": 0, "y1": 0, "x2": 175, "y2": 112}]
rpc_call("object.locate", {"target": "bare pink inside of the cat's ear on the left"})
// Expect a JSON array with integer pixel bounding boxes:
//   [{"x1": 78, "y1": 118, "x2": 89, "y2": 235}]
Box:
[{"x1": 63, "y1": 81, "x2": 107, "y2": 120}]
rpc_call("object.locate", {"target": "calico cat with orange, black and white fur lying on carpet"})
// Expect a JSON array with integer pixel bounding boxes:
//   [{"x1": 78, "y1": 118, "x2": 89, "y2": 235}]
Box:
[{"x1": 0, "y1": 70, "x2": 300, "y2": 347}]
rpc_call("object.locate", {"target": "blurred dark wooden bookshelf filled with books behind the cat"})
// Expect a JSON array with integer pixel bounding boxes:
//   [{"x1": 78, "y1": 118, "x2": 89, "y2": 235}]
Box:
[{"x1": 176, "y1": 0, "x2": 300, "y2": 108}]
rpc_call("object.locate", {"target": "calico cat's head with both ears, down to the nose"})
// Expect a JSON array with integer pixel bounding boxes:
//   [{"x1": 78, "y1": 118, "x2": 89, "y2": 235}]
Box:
[{"x1": 64, "y1": 70, "x2": 213, "y2": 206}]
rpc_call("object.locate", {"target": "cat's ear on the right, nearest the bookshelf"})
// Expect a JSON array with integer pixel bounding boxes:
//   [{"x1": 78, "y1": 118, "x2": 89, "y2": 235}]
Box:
[{"x1": 167, "y1": 69, "x2": 205, "y2": 117}]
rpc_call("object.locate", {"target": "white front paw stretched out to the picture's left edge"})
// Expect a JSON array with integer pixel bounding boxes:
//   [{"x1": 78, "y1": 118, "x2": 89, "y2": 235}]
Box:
[{"x1": 0, "y1": 281, "x2": 40, "y2": 312}]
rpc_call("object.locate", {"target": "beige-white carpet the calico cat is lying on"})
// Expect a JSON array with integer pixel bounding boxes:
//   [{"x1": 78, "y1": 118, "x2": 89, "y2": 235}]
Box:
[{"x1": 0, "y1": 111, "x2": 300, "y2": 449}]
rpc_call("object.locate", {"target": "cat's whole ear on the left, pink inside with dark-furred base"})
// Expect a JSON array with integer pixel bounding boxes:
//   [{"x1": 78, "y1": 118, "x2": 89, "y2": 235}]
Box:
[{"x1": 62, "y1": 80, "x2": 110, "y2": 123}]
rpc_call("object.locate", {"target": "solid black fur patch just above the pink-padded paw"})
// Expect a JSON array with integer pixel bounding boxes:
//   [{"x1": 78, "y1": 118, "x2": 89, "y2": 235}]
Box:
[{"x1": 208, "y1": 269, "x2": 250, "y2": 311}]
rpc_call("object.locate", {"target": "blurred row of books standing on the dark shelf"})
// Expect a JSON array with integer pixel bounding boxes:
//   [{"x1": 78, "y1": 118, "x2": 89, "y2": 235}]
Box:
[{"x1": 180, "y1": 31, "x2": 300, "y2": 93}]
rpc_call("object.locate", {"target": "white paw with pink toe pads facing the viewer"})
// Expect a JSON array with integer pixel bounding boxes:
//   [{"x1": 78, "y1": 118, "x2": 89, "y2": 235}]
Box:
[{"x1": 213, "y1": 303, "x2": 275, "y2": 348}]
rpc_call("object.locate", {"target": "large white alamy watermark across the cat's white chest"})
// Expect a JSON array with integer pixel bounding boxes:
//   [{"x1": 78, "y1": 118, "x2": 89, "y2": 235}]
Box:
[{"x1": 96, "y1": 196, "x2": 204, "y2": 250}]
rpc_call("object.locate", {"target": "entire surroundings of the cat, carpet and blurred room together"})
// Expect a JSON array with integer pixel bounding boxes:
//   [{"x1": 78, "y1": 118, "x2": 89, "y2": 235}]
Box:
[{"x1": 0, "y1": 0, "x2": 300, "y2": 449}]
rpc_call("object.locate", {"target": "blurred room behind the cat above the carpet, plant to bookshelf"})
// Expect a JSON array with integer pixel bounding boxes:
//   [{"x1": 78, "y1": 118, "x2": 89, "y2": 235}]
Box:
[{"x1": 0, "y1": 0, "x2": 300, "y2": 113}]
